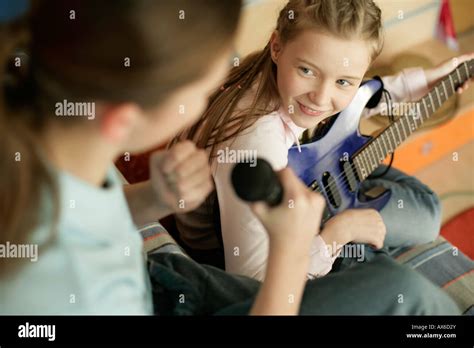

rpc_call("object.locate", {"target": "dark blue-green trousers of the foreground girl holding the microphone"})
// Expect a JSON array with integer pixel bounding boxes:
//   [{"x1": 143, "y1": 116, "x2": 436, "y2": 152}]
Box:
[{"x1": 148, "y1": 253, "x2": 460, "y2": 315}]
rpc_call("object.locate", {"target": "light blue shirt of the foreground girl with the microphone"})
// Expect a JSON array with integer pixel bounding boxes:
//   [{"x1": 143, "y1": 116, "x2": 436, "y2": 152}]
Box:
[{"x1": 0, "y1": 169, "x2": 152, "y2": 314}]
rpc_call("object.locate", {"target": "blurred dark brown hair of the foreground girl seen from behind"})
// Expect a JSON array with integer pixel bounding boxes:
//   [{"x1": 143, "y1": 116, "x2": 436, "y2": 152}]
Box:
[{"x1": 0, "y1": 0, "x2": 241, "y2": 274}]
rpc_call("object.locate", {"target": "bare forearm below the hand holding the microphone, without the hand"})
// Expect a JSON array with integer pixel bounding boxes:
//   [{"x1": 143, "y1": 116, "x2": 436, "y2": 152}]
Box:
[{"x1": 250, "y1": 245, "x2": 309, "y2": 315}]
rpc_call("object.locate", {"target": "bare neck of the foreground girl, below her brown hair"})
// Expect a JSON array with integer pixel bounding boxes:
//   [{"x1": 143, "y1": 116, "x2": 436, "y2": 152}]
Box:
[{"x1": 42, "y1": 125, "x2": 116, "y2": 187}]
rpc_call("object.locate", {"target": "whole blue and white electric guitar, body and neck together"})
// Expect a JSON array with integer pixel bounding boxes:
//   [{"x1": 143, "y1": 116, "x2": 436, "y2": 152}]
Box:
[{"x1": 288, "y1": 60, "x2": 474, "y2": 221}]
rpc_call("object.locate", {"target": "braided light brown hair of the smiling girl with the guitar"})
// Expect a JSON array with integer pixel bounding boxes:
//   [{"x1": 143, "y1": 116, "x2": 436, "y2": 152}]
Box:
[{"x1": 176, "y1": 0, "x2": 383, "y2": 162}]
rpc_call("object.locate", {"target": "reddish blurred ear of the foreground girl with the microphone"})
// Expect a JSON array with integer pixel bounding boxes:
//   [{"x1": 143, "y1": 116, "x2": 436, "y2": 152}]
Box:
[{"x1": 99, "y1": 103, "x2": 140, "y2": 145}]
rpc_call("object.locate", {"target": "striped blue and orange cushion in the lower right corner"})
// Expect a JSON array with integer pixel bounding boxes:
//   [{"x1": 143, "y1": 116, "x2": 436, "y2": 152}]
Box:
[{"x1": 391, "y1": 237, "x2": 474, "y2": 315}]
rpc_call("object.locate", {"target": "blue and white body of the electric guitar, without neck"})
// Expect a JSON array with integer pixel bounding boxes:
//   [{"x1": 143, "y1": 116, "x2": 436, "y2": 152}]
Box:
[{"x1": 288, "y1": 80, "x2": 391, "y2": 218}]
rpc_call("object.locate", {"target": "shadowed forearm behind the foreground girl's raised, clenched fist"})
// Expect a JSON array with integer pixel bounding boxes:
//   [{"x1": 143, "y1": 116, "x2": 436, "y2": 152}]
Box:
[{"x1": 124, "y1": 180, "x2": 173, "y2": 226}]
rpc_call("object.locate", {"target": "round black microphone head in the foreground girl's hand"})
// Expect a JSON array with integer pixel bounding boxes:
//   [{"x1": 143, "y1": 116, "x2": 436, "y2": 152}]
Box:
[{"x1": 231, "y1": 158, "x2": 283, "y2": 206}]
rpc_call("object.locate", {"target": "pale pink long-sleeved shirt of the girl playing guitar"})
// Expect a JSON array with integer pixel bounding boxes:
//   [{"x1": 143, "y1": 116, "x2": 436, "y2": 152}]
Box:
[{"x1": 176, "y1": 68, "x2": 428, "y2": 280}]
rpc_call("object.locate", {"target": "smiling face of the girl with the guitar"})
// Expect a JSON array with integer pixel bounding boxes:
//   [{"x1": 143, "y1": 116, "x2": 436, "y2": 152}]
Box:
[{"x1": 271, "y1": 30, "x2": 371, "y2": 128}]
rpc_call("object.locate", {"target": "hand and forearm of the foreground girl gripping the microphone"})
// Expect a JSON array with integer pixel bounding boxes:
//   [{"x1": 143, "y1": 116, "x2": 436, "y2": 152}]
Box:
[{"x1": 250, "y1": 168, "x2": 325, "y2": 315}]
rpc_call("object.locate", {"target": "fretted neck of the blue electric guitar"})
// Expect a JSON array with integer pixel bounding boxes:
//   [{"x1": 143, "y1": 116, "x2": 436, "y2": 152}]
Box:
[{"x1": 352, "y1": 59, "x2": 474, "y2": 181}]
